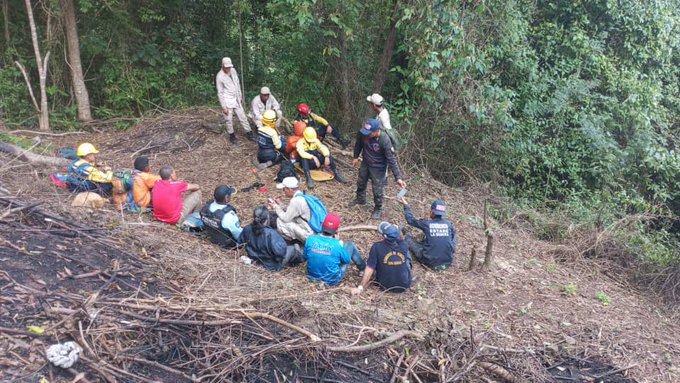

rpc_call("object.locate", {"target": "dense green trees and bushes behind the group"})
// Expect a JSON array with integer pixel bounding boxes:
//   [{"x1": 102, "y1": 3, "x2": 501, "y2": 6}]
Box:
[{"x1": 0, "y1": 0, "x2": 680, "y2": 272}]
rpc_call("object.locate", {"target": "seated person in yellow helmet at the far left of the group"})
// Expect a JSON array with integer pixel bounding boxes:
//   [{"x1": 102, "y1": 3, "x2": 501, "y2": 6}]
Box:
[{"x1": 67, "y1": 142, "x2": 113, "y2": 196}]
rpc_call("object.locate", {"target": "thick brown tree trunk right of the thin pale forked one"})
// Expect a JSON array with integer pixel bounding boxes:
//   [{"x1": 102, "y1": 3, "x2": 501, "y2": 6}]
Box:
[{"x1": 59, "y1": 0, "x2": 92, "y2": 122}]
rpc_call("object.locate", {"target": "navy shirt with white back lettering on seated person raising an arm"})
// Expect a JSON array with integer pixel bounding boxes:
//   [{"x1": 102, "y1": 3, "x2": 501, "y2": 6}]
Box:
[{"x1": 404, "y1": 205, "x2": 458, "y2": 268}]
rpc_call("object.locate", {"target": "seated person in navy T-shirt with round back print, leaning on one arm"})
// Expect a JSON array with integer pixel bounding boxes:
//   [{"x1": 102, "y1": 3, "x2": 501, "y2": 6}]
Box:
[{"x1": 351, "y1": 222, "x2": 412, "y2": 295}]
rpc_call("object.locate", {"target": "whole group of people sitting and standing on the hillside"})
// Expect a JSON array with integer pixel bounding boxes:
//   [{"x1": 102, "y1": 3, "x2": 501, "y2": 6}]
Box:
[{"x1": 57, "y1": 57, "x2": 457, "y2": 294}]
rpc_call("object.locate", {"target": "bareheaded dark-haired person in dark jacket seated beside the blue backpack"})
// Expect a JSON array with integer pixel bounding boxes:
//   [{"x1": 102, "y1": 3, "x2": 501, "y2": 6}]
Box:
[{"x1": 239, "y1": 205, "x2": 303, "y2": 271}]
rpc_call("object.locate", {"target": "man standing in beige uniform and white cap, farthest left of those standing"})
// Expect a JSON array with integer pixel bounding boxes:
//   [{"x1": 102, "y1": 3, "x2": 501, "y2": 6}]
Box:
[{"x1": 215, "y1": 57, "x2": 255, "y2": 144}]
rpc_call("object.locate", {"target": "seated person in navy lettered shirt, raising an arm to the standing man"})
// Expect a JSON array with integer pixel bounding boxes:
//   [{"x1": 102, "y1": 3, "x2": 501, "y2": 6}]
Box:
[{"x1": 399, "y1": 197, "x2": 458, "y2": 271}]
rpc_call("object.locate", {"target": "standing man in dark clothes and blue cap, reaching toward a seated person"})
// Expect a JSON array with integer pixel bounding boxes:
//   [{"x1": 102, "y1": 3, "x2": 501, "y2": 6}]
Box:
[{"x1": 350, "y1": 118, "x2": 406, "y2": 219}]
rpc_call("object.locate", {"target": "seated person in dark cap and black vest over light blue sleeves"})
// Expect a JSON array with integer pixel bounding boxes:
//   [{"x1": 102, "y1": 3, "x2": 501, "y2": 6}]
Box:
[{"x1": 201, "y1": 185, "x2": 243, "y2": 249}]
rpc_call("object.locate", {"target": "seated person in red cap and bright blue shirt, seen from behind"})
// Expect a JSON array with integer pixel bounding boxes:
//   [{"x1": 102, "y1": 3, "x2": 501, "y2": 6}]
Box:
[{"x1": 303, "y1": 213, "x2": 366, "y2": 286}]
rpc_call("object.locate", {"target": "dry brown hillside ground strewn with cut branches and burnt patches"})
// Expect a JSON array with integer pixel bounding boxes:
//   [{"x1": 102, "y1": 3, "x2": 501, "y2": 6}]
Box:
[{"x1": 0, "y1": 109, "x2": 680, "y2": 382}]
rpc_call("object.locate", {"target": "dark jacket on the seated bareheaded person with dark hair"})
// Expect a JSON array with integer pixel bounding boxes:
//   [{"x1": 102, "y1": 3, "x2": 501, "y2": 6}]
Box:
[{"x1": 239, "y1": 224, "x2": 287, "y2": 271}]
